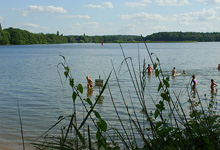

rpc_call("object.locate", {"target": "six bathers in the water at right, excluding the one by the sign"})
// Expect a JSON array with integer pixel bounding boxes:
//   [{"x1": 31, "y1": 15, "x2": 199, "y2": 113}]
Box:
[{"x1": 145, "y1": 64, "x2": 220, "y2": 93}]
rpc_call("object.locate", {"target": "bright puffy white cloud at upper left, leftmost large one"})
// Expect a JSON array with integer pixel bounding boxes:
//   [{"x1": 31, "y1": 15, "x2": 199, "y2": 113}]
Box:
[{"x1": 22, "y1": 5, "x2": 67, "y2": 16}]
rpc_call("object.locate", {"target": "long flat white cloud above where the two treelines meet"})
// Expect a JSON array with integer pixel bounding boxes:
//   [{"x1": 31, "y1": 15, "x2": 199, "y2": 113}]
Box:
[{"x1": 118, "y1": 12, "x2": 170, "y2": 21}]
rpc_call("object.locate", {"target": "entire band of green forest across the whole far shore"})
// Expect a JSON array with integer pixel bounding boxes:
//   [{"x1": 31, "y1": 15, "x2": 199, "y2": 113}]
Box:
[{"x1": 0, "y1": 24, "x2": 220, "y2": 45}]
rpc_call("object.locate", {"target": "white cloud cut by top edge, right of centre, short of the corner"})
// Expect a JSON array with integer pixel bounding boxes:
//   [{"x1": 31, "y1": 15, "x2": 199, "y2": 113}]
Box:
[{"x1": 156, "y1": 0, "x2": 189, "y2": 6}]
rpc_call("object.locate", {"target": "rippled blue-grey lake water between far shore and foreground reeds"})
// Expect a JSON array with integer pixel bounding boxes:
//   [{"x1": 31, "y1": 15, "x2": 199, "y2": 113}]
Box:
[{"x1": 0, "y1": 42, "x2": 220, "y2": 149}]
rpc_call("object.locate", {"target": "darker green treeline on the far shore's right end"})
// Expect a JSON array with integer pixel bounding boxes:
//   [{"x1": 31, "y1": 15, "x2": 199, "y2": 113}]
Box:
[{"x1": 145, "y1": 32, "x2": 220, "y2": 42}]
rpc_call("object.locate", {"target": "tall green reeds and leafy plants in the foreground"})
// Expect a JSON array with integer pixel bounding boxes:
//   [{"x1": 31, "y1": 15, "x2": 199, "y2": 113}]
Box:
[{"x1": 32, "y1": 38, "x2": 220, "y2": 150}]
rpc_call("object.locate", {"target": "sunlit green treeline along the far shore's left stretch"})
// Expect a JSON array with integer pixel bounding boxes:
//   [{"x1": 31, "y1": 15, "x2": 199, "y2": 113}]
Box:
[{"x1": 0, "y1": 26, "x2": 142, "y2": 45}]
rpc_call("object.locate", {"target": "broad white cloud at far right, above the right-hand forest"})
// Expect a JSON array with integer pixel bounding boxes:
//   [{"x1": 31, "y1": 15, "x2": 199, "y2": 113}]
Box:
[{"x1": 174, "y1": 9, "x2": 218, "y2": 25}]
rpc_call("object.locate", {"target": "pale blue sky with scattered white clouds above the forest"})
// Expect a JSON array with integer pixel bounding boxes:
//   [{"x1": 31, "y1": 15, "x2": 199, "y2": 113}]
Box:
[{"x1": 0, "y1": 0, "x2": 220, "y2": 36}]
